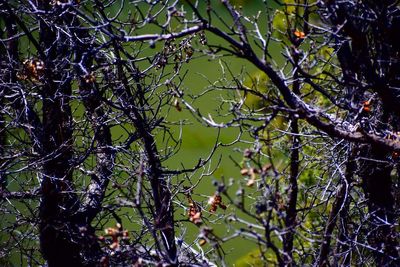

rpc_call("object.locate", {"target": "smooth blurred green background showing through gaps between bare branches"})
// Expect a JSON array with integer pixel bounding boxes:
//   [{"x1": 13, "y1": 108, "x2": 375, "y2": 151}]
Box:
[{"x1": 3, "y1": 0, "x2": 279, "y2": 267}]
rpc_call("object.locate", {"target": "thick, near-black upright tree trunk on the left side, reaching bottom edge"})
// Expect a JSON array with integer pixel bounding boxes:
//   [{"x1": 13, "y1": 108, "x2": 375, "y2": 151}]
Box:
[{"x1": 39, "y1": 3, "x2": 90, "y2": 266}]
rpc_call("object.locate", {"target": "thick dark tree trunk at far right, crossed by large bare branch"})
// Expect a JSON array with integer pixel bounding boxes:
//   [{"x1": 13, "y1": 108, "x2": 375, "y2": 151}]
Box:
[{"x1": 326, "y1": 1, "x2": 400, "y2": 266}]
